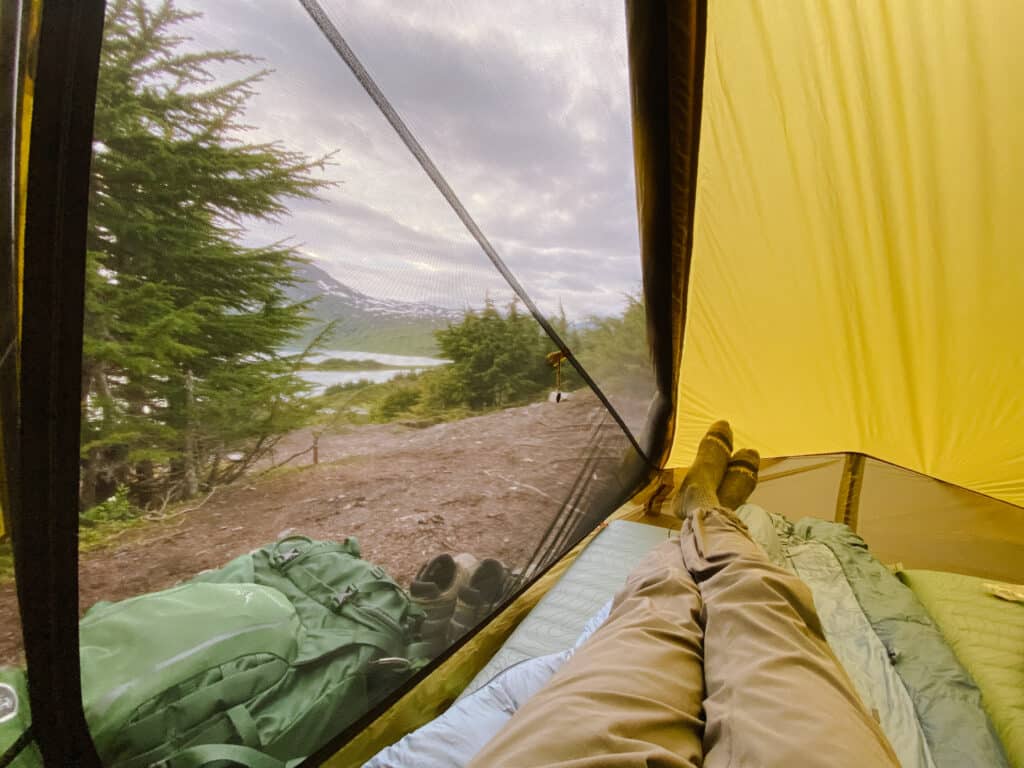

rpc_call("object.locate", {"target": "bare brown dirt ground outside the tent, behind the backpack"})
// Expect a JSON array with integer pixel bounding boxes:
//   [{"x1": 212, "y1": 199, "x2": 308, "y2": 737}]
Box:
[{"x1": 0, "y1": 395, "x2": 627, "y2": 664}]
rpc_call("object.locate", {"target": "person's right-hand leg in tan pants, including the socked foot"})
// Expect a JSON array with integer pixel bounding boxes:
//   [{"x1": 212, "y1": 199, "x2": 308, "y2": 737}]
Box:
[{"x1": 680, "y1": 425, "x2": 899, "y2": 768}]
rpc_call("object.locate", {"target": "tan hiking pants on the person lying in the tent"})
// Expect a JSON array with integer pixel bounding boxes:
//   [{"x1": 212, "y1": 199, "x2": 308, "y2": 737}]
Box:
[{"x1": 471, "y1": 509, "x2": 899, "y2": 768}]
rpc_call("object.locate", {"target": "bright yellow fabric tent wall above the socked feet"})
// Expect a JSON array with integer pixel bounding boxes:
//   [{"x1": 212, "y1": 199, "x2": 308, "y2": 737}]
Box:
[{"x1": 669, "y1": 0, "x2": 1024, "y2": 504}]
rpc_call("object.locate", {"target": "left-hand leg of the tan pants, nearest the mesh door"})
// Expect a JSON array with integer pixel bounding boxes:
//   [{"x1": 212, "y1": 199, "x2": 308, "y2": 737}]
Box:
[{"x1": 471, "y1": 540, "x2": 703, "y2": 768}]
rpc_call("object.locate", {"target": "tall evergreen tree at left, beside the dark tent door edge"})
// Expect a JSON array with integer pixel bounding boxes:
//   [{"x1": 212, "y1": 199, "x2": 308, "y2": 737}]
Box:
[{"x1": 82, "y1": 0, "x2": 327, "y2": 509}]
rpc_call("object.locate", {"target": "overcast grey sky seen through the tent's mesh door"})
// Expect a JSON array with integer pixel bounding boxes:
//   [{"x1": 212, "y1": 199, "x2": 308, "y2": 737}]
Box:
[{"x1": 178, "y1": 0, "x2": 640, "y2": 318}]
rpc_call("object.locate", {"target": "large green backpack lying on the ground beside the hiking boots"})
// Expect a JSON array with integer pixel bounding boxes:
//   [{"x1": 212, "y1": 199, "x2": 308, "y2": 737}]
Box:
[{"x1": 80, "y1": 537, "x2": 426, "y2": 768}]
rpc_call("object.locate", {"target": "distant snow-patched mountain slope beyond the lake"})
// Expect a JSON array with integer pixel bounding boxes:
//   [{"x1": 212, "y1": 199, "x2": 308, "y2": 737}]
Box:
[{"x1": 288, "y1": 264, "x2": 462, "y2": 356}]
